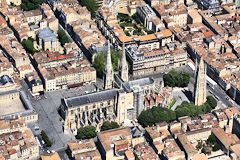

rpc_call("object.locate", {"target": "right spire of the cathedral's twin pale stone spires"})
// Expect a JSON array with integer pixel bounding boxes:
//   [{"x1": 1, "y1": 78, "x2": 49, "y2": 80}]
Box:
[{"x1": 120, "y1": 43, "x2": 128, "y2": 82}]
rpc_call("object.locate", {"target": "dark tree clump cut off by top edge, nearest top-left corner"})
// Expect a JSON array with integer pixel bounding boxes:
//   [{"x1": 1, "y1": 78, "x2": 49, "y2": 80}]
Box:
[{"x1": 20, "y1": 0, "x2": 44, "y2": 11}]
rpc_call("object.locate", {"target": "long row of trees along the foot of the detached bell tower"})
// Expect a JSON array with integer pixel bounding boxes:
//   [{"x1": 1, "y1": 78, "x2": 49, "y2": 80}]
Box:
[{"x1": 138, "y1": 96, "x2": 217, "y2": 127}]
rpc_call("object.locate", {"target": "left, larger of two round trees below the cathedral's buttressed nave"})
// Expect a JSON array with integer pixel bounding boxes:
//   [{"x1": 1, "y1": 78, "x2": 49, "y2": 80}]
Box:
[{"x1": 76, "y1": 126, "x2": 97, "y2": 139}]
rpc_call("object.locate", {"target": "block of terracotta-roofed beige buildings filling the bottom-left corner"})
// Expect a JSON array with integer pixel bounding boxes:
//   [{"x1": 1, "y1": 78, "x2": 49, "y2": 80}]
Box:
[{"x1": 0, "y1": 119, "x2": 39, "y2": 160}]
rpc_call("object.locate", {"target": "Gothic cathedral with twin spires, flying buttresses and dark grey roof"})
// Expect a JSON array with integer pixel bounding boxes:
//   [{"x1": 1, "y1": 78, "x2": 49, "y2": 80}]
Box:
[{"x1": 60, "y1": 42, "x2": 163, "y2": 134}]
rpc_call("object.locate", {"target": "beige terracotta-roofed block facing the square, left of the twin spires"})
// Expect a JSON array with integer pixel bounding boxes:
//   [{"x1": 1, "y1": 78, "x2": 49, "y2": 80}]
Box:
[{"x1": 34, "y1": 50, "x2": 96, "y2": 91}]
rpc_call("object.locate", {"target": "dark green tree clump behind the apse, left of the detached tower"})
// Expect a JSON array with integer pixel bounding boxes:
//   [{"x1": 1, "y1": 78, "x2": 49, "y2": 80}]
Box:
[{"x1": 163, "y1": 69, "x2": 190, "y2": 87}]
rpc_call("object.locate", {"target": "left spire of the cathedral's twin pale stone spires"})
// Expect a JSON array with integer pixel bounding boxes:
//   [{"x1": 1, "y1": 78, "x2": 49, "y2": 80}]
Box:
[{"x1": 104, "y1": 40, "x2": 113, "y2": 89}]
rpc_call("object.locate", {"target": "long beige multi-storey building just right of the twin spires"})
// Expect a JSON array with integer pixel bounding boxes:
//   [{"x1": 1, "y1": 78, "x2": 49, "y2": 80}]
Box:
[{"x1": 126, "y1": 44, "x2": 187, "y2": 77}]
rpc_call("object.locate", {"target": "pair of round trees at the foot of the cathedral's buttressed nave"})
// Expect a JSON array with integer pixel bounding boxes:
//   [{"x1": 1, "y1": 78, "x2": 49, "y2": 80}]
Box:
[{"x1": 76, "y1": 121, "x2": 119, "y2": 139}]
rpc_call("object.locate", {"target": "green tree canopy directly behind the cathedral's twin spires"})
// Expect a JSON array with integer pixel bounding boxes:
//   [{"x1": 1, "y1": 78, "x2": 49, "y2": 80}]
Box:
[{"x1": 93, "y1": 50, "x2": 121, "y2": 78}]
